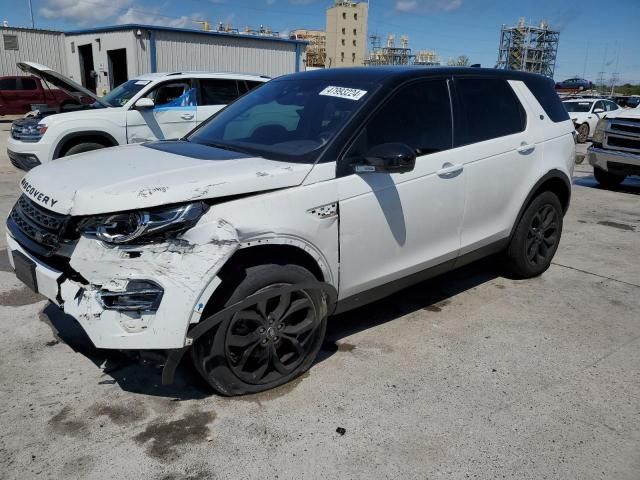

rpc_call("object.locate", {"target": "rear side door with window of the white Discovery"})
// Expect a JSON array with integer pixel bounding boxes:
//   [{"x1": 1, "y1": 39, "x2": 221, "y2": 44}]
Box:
[{"x1": 454, "y1": 78, "x2": 544, "y2": 251}]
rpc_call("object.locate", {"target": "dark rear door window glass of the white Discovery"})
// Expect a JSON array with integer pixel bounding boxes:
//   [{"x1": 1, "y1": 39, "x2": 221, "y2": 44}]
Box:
[{"x1": 454, "y1": 78, "x2": 526, "y2": 146}]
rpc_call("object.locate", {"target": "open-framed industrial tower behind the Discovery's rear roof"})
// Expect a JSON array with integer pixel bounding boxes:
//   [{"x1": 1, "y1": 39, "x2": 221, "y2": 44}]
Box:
[{"x1": 496, "y1": 18, "x2": 560, "y2": 77}]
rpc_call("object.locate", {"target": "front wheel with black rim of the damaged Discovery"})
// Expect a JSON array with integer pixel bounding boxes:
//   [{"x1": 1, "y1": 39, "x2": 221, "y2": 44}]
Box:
[{"x1": 191, "y1": 264, "x2": 327, "y2": 396}]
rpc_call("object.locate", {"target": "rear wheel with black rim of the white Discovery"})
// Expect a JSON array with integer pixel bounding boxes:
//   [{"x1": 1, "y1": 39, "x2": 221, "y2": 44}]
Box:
[{"x1": 506, "y1": 191, "x2": 563, "y2": 278}]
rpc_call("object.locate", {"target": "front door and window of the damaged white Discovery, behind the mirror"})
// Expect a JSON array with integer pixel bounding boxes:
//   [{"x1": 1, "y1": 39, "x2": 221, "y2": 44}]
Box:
[{"x1": 337, "y1": 79, "x2": 465, "y2": 298}]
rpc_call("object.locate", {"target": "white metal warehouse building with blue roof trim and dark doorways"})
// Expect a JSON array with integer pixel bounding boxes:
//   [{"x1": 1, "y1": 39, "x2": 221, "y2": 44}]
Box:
[{"x1": 0, "y1": 24, "x2": 306, "y2": 95}]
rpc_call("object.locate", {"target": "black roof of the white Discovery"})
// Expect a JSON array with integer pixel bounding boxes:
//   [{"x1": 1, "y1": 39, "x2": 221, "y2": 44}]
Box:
[{"x1": 279, "y1": 66, "x2": 549, "y2": 83}]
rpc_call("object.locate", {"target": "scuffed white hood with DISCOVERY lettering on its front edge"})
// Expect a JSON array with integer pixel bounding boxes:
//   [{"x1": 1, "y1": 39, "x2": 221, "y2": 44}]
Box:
[{"x1": 20, "y1": 141, "x2": 313, "y2": 215}]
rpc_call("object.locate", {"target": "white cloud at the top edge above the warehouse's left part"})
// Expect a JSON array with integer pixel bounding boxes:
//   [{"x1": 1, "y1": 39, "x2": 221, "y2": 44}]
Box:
[{"x1": 38, "y1": 0, "x2": 132, "y2": 25}]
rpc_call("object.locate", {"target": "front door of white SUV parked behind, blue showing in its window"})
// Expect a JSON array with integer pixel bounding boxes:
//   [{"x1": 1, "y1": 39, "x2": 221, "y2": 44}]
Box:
[{"x1": 127, "y1": 80, "x2": 197, "y2": 143}]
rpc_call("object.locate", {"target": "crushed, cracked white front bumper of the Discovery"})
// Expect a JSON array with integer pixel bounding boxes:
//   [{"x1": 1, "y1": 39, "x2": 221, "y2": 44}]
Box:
[{"x1": 7, "y1": 223, "x2": 238, "y2": 350}]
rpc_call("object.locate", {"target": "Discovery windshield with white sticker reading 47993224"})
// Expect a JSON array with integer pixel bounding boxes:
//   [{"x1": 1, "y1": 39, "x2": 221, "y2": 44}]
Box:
[{"x1": 188, "y1": 79, "x2": 377, "y2": 163}]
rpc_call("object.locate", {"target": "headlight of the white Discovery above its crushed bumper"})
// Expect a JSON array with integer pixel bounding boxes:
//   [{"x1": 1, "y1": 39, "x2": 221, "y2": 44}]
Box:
[{"x1": 78, "y1": 202, "x2": 209, "y2": 244}]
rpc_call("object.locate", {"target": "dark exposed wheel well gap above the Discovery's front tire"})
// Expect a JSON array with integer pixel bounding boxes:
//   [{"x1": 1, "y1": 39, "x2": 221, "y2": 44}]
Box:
[{"x1": 201, "y1": 244, "x2": 324, "y2": 319}]
